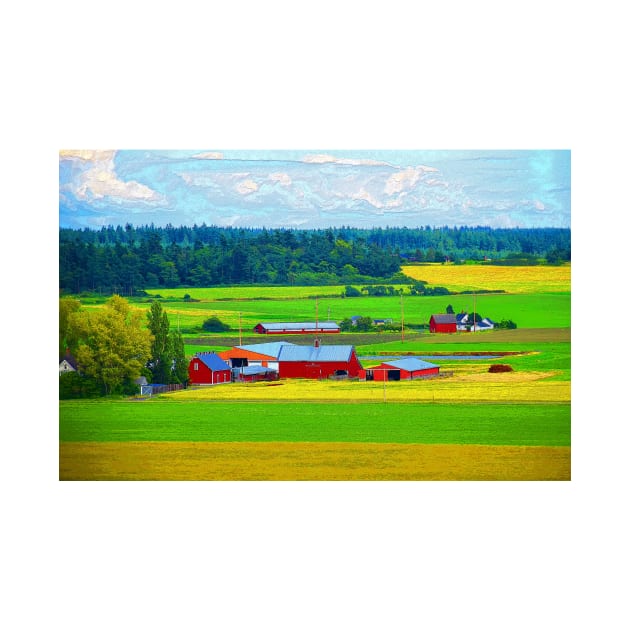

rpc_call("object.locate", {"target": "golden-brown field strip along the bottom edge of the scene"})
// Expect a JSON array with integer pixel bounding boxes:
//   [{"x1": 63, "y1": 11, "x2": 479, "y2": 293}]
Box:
[{"x1": 59, "y1": 442, "x2": 571, "y2": 481}]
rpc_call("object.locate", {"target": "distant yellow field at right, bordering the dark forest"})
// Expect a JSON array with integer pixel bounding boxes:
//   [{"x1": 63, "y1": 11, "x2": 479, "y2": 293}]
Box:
[{"x1": 402, "y1": 264, "x2": 571, "y2": 293}]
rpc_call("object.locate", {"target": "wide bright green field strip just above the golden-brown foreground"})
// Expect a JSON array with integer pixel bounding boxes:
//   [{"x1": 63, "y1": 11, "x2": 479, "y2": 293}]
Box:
[{"x1": 59, "y1": 399, "x2": 571, "y2": 446}]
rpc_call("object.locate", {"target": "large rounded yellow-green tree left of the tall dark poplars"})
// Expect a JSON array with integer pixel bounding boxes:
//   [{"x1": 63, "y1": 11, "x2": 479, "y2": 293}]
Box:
[{"x1": 70, "y1": 295, "x2": 153, "y2": 394}]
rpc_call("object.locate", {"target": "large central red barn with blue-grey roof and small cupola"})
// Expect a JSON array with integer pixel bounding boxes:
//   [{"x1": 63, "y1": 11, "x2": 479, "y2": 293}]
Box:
[{"x1": 278, "y1": 346, "x2": 362, "y2": 378}]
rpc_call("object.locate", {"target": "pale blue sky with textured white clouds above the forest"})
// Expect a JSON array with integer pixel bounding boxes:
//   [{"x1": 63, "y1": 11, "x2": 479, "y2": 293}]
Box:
[{"x1": 59, "y1": 149, "x2": 571, "y2": 228}]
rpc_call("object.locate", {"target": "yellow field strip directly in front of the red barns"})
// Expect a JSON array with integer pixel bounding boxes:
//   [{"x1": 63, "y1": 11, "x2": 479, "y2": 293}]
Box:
[{"x1": 163, "y1": 371, "x2": 571, "y2": 403}]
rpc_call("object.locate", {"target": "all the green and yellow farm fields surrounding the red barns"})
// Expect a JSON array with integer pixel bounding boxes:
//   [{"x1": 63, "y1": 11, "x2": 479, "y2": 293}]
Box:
[{"x1": 59, "y1": 265, "x2": 571, "y2": 480}]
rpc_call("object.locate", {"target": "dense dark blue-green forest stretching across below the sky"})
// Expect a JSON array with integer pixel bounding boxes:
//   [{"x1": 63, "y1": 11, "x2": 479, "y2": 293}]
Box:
[{"x1": 59, "y1": 224, "x2": 571, "y2": 295}]
